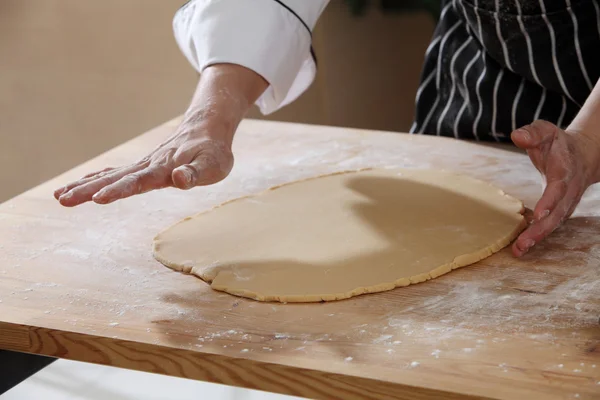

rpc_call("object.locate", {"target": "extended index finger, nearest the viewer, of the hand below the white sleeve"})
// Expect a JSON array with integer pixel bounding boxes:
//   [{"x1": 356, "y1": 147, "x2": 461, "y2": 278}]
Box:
[{"x1": 92, "y1": 167, "x2": 171, "y2": 204}]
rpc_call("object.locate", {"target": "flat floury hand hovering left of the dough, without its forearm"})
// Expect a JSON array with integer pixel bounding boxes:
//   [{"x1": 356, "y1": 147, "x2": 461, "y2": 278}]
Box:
[{"x1": 54, "y1": 124, "x2": 233, "y2": 207}]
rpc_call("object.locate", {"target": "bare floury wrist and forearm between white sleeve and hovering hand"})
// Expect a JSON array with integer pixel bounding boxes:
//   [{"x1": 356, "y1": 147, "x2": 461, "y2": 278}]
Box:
[{"x1": 181, "y1": 64, "x2": 269, "y2": 145}]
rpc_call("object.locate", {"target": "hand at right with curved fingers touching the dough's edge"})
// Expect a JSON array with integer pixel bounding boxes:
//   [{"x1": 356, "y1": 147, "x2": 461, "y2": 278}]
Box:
[{"x1": 511, "y1": 120, "x2": 600, "y2": 257}]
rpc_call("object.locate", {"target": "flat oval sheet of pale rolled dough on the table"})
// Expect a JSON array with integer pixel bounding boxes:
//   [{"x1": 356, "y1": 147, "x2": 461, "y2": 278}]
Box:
[{"x1": 154, "y1": 169, "x2": 526, "y2": 302}]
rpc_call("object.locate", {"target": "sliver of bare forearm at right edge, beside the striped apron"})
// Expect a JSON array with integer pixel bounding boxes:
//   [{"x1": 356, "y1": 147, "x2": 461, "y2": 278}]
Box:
[{"x1": 567, "y1": 80, "x2": 600, "y2": 182}]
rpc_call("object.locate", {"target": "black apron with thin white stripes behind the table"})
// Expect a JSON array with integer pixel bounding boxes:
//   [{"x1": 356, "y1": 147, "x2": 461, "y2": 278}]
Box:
[{"x1": 411, "y1": 0, "x2": 600, "y2": 141}]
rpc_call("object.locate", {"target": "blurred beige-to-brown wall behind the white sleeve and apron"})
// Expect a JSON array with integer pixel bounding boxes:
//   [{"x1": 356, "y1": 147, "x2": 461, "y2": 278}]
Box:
[{"x1": 0, "y1": 0, "x2": 434, "y2": 201}]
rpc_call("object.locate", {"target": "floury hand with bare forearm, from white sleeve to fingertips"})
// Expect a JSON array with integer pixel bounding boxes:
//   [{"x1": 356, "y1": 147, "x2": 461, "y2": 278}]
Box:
[{"x1": 54, "y1": 64, "x2": 268, "y2": 207}]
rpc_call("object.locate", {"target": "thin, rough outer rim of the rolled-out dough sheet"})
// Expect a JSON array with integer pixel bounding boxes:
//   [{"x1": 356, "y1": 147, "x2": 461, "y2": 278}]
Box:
[{"x1": 152, "y1": 167, "x2": 527, "y2": 303}]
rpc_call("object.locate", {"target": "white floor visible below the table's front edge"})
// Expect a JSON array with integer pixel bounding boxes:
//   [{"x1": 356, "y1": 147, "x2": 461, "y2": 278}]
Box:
[{"x1": 0, "y1": 360, "x2": 302, "y2": 400}]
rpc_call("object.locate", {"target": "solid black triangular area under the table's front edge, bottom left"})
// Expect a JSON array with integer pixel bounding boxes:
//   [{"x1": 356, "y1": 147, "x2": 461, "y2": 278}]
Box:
[{"x1": 0, "y1": 350, "x2": 56, "y2": 395}]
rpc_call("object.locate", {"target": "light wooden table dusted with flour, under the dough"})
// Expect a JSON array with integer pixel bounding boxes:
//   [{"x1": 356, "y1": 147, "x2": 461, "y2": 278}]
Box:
[{"x1": 0, "y1": 121, "x2": 600, "y2": 399}]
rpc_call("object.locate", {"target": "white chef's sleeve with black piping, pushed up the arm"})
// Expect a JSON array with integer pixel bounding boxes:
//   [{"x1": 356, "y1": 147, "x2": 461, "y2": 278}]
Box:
[{"x1": 173, "y1": 0, "x2": 329, "y2": 114}]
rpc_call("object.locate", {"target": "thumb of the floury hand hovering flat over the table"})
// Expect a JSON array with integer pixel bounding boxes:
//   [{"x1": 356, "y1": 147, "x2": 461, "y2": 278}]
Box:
[{"x1": 171, "y1": 151, "x2": 233, "y2": 190}]
